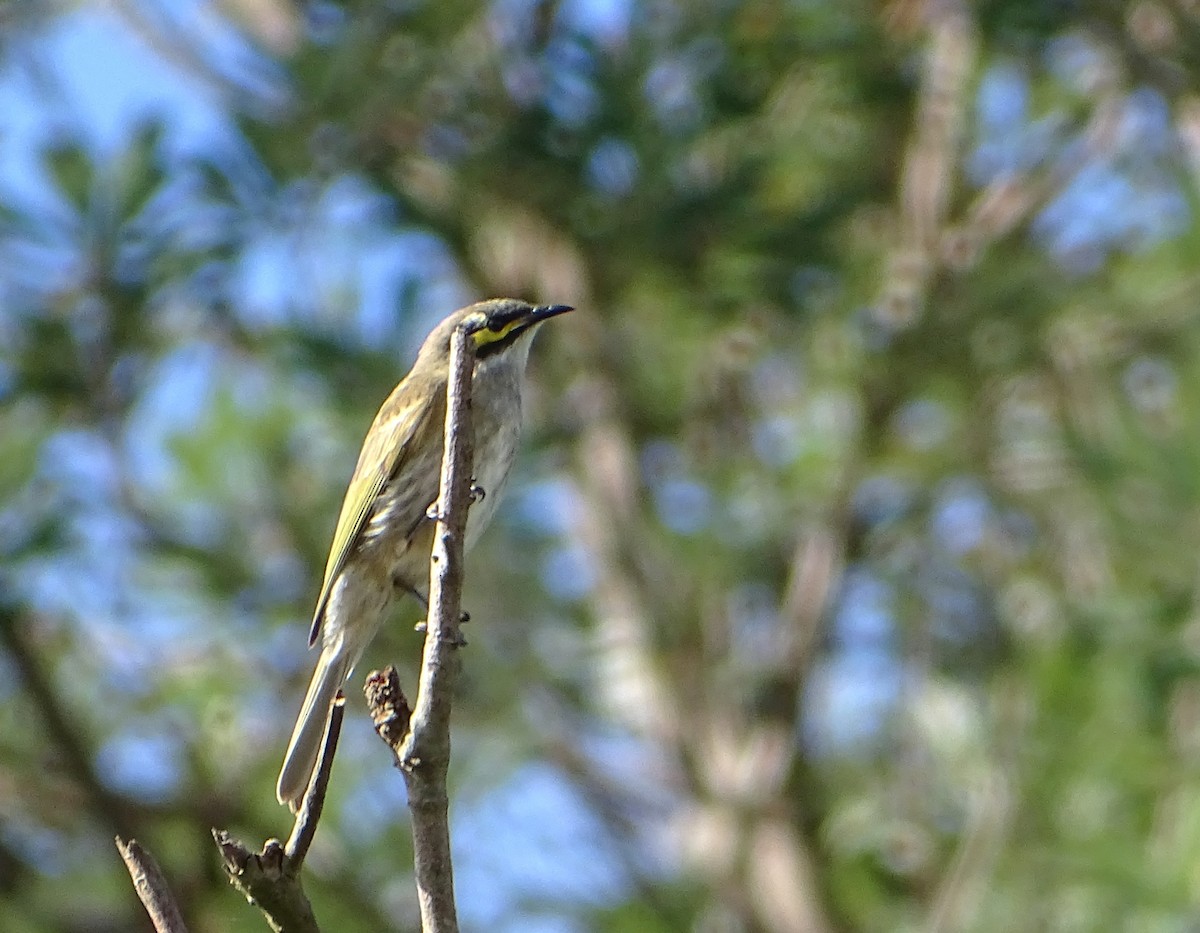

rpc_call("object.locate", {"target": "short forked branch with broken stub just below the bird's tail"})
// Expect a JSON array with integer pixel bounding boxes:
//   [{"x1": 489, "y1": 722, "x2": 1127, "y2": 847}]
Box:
[{"x1": 212, "y1": 691, "x2": 346, "y2": 933}]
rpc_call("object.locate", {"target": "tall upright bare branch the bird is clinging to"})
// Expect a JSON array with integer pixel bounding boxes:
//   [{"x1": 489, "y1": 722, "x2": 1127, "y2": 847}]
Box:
[{"x1": 366, "y1": 319, "x2": 478, "y2": 933}]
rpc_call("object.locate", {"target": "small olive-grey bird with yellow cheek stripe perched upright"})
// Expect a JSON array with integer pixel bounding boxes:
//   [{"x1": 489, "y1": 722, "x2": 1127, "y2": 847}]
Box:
[{"x1": 275, "y1": 299, "x2": 571, "y2": 811}]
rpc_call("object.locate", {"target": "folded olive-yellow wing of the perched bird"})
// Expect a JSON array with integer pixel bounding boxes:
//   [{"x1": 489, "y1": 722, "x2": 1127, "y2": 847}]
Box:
[{"x1": 308, "y1": 391, "x2": 445, "y2": 646}]
